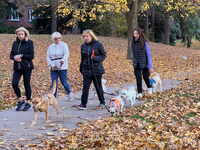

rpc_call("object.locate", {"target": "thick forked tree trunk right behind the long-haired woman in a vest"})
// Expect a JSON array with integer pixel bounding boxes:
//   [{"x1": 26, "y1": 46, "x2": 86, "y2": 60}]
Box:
[{"x1": 125, "y1": 0, "x2": 146, "y2": 60}]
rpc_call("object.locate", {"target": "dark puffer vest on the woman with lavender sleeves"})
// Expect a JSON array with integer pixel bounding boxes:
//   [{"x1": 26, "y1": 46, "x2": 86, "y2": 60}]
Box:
[{"x1": 133, "y1": 41, "x2": 148, "y2": 69}]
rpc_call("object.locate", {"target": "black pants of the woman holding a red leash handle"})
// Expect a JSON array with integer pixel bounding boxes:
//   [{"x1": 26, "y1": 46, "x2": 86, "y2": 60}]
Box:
[{"x1": 81, "y1": 75, "x2": 105, "y2": 107}]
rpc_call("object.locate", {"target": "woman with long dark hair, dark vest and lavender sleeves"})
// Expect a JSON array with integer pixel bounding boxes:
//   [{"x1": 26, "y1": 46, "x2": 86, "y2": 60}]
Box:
[{"x1": 131, "y1": 27, "x2": 153, "y2": 98}]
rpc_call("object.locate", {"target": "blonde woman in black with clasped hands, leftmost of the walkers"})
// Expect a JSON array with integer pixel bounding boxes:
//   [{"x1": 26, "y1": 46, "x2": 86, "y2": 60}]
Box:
[{"x1": 10, "y1": 27, "x2": 34, "y2": 111}]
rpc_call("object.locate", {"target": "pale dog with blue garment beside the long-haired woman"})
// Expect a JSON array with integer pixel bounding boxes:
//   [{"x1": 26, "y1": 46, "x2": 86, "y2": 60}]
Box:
[{"x1": 150, "y1": 72, "x2": 162, "y2": 93}]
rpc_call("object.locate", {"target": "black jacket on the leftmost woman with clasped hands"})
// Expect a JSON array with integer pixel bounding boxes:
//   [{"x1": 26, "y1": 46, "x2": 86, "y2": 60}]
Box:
[{"x1": 10, "y1": 38, "x2": 34, "y2": 70}]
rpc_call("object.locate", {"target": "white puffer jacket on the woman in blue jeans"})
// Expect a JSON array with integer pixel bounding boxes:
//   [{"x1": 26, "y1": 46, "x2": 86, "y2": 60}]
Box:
[{"x1": 47, "y1": 41, "x2": 69, "y2": 70}]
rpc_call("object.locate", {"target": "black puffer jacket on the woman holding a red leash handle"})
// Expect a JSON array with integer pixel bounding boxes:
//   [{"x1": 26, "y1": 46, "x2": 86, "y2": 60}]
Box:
[{"x1": 80, "y1": 40, "x2": 106, "y2": 76}]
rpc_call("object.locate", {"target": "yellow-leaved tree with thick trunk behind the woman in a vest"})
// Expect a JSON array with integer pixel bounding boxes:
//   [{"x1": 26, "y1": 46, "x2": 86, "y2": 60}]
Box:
[{"x1": 57, "y1": 0, "x2": 147, "y2": 59}]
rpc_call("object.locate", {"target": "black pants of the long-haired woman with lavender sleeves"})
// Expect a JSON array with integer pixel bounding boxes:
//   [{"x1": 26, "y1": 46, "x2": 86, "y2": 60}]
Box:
[{"x1": 134, "y1": 64, "x2": 151, "y2": 93}]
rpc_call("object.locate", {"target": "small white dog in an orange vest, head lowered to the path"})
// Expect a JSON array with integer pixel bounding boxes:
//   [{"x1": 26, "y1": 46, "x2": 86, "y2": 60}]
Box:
[{"x1": 108, "y1": 96, "x2": 124, "y2": 117}]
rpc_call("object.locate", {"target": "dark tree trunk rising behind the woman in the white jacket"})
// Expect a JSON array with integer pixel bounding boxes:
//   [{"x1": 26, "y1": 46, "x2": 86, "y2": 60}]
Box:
[{"x1": 51, "y1": 0, "x2": 57, "y2": 33}]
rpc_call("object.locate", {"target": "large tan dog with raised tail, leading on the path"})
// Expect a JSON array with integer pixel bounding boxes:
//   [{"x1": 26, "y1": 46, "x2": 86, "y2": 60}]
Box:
[{"x1": 32, "y1": 80, "x2": 59, "y2": 124}]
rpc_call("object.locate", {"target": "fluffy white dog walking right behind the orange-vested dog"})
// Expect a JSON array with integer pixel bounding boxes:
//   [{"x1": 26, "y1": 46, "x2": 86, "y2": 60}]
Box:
[{"x1": 119, "y1": 87, "x2": 136, "y2": 107}]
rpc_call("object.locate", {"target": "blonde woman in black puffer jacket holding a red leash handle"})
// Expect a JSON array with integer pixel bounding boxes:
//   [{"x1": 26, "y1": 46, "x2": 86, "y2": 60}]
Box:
[{"x1": 75, "y1": 30, "x2": 106, "y2": 110}]
